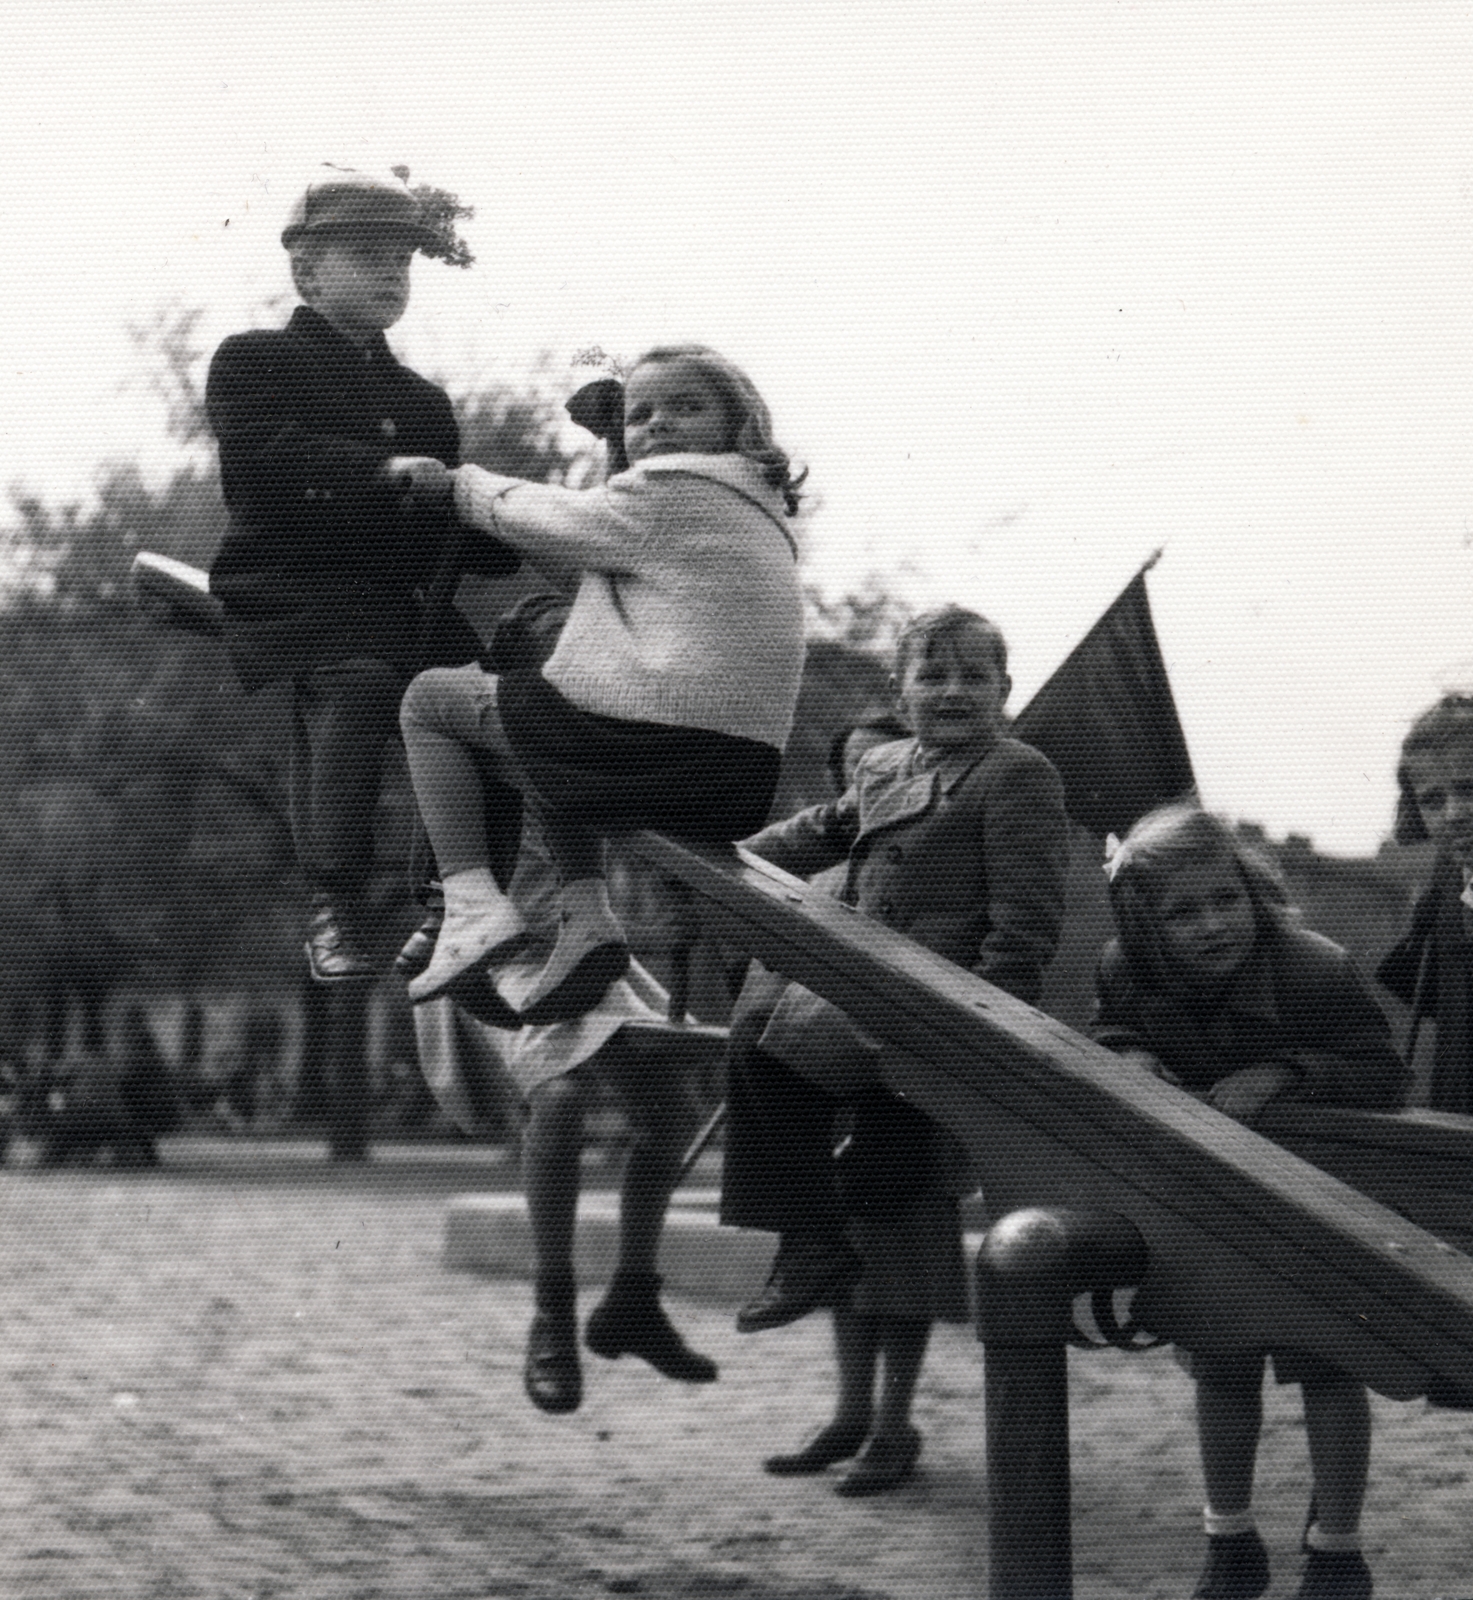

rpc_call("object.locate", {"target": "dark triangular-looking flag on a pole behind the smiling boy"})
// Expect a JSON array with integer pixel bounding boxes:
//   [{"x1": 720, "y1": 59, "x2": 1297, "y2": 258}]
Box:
[{"x1": 1009, "y1": 558, "x2": 1196, "y2": 835}]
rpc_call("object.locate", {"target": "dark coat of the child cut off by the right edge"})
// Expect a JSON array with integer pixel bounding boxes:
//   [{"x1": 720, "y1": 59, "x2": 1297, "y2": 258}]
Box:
[{"x1": 1375, "y1": 856, "x2": 1473, "y2": 1117}]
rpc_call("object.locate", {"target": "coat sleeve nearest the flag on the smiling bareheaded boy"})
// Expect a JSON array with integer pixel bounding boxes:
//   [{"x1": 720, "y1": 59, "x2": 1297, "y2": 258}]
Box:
[{"x1": 972, "y1": 747, "x2": 1068, "y2": 1005}]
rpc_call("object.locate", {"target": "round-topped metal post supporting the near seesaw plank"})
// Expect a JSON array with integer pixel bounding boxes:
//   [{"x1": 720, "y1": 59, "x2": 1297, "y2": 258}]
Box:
[{"x1": 977, "y1": 1206, "x2": 1147, "y2": 1600}]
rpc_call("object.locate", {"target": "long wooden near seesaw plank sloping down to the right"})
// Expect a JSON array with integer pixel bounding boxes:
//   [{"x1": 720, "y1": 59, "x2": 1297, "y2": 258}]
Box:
[{"x1": 625, "y1": 832, "x2": 1473, "y2": 1398}]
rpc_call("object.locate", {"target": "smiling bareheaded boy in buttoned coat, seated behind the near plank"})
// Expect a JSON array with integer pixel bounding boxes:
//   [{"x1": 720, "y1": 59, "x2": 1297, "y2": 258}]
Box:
[{"x1": 721, "y1": 606, "x2": 1068, "y2": 1333}]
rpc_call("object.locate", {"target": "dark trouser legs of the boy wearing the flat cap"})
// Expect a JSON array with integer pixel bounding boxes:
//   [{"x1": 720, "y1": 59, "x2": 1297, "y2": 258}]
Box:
[{"x1": 291, "y1": 656, "x2": 405, "y2": 894}]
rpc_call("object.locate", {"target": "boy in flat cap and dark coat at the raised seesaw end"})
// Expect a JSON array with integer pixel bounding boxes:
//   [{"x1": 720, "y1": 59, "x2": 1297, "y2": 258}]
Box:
[{"x1": 205, "y1": 168, "x2": 517, "y2": 982}]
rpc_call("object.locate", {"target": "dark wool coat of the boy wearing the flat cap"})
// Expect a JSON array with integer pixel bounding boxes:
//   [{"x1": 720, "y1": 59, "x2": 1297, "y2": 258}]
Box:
[{"x1": 205, "y1": 306, "x2": 517, "y2": 691}]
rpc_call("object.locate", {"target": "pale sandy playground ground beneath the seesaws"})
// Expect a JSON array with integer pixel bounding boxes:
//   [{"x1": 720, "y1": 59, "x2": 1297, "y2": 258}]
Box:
[{"x1": 0, "y1": 1144, "x2": 1473, "y2": 1600}]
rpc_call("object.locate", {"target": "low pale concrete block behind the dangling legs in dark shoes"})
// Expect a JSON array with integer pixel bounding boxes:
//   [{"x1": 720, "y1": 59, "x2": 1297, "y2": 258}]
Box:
[{"x1": 445, "y1": 1190, "x2": 776, "y2": 1306}]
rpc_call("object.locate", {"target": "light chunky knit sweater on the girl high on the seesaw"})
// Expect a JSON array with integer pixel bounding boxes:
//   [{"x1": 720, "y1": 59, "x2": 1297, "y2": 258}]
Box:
[{"x1": 456, "y1": 454, "x2": 803, "y2": 750}]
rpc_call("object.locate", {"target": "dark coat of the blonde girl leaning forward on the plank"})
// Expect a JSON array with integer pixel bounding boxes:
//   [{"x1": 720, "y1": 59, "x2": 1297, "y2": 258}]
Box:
[{"x1": 1089, "y1": 926, "x2": 1411, "y2": 1110}]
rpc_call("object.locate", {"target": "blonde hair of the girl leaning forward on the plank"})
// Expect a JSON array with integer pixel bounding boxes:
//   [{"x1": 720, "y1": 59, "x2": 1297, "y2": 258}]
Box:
[{"x1": 1105, "y1": 803, "x2": 1294, "y2": 981}]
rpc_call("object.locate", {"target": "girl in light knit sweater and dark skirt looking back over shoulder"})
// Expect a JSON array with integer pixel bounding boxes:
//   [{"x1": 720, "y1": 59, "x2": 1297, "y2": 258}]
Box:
[{"x1": 400, "y1": 346, "x2": 803, "y2": 1022}]
